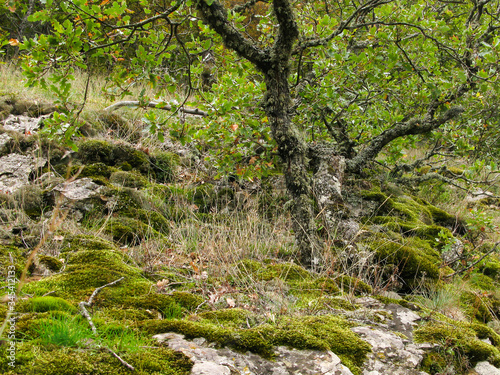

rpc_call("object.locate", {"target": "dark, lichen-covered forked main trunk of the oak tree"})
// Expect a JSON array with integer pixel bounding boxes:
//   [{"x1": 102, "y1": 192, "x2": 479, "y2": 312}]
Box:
[{"x1": 198, "y1": 0, "x2": 320, "y2": 269}]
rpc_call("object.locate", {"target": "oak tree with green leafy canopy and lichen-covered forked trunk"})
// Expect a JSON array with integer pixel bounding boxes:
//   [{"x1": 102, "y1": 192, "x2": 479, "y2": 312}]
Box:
[{"x1": 6, "y1": 0, "x2": 500, "y2": 268}]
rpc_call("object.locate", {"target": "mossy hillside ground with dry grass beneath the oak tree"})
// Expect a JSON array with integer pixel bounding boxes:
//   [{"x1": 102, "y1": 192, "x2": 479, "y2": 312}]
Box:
[{"x1": 0, "y1": 92, "x2": 500, "y2": 375}]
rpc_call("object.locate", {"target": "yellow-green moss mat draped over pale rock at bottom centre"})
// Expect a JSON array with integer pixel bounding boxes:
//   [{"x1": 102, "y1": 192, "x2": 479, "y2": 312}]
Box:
[{"x1": 141, "y1": 310, "x2": 370, "y2": 374}]
